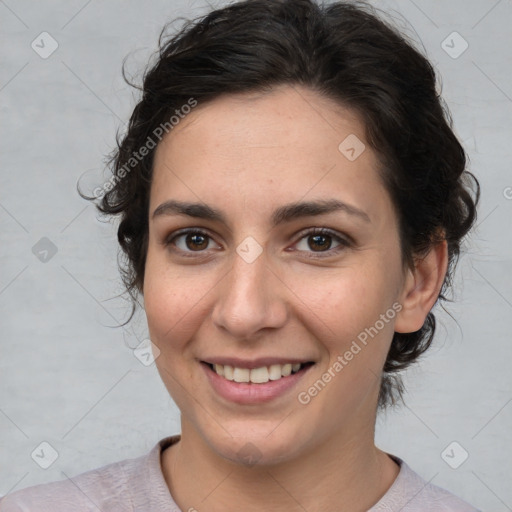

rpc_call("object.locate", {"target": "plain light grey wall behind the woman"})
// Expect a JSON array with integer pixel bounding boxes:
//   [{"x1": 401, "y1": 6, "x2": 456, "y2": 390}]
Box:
[{"x1": 0, "y1": 0, "x2": 512, "y2": 512}]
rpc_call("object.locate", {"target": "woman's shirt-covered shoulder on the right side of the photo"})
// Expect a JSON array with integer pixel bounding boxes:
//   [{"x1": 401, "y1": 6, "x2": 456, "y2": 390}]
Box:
[{"x1": 369, "y1": 455, "x2": 481, "y2": 512}]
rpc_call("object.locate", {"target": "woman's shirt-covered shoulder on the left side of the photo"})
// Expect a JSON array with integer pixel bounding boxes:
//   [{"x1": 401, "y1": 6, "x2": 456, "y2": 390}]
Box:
[{"x1": 0, "y1": 438, "x2": 180, "y2": 512}]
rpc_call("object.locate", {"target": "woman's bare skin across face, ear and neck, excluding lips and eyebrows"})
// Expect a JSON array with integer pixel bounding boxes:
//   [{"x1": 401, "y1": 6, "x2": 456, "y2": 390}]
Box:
[{"x1": 143, "y1": 86, "x2": 447, "y2": 512}]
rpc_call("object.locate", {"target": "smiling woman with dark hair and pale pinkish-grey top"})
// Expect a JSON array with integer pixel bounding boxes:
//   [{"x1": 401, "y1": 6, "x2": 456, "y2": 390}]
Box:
[{"x1": 0, "y1": 0, "x2": 479, "y2": 512}]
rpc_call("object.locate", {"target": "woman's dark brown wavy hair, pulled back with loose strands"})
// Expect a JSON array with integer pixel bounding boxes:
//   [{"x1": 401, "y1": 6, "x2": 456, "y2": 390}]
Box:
[{"x1": 80, "y1": 0, "x2": 480, "y2": 408}]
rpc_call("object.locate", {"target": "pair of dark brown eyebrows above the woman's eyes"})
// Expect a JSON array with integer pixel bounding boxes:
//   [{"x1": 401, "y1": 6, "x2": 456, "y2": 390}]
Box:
[{"x1": 152, "y1": 199, "x2": 371, "y2": 227}]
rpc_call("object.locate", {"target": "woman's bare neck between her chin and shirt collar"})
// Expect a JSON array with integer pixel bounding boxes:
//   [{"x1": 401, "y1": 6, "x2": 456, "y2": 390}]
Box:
[{"x1": 162, "y1": 412, "x2": 399, "y2": 512}]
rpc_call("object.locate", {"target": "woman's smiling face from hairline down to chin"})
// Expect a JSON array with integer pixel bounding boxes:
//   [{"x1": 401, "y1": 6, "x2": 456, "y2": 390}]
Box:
[{"x1": 143, "y1": 86, "x2": 404, "y2": 464}]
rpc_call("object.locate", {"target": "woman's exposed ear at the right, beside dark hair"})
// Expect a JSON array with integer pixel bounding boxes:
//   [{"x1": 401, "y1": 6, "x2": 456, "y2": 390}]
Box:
[{"x1": 395, "y1": 240, "x2": 448, "y2": 333}]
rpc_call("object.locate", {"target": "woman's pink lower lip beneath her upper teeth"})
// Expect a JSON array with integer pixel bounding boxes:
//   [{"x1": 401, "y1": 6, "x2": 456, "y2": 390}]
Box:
[{"x1": 201, "y1": 363, "x2": 313, "y2": 404}]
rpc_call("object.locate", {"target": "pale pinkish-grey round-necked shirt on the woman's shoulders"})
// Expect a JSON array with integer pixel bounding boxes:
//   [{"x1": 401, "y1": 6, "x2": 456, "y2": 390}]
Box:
[{"x1": 0, "y1": 435, "x2": 480, "y2": 512}]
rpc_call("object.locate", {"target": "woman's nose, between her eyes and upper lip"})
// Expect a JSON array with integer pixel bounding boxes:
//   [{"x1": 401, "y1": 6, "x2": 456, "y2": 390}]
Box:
[{"x1": 212, "y1": 244, "x2": 288, "y2": 341}]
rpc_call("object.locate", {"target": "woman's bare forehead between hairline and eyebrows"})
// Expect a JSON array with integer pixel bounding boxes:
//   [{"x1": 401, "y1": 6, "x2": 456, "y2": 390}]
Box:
[{"x1": 151, "y1": 86, "x2": 389, "y2": 226}]
